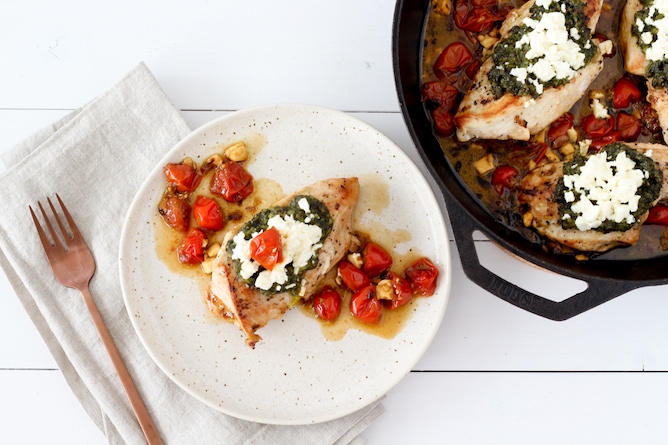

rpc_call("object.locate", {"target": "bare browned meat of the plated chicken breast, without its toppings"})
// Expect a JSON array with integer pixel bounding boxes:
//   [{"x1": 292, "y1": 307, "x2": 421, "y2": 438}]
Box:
[{"x1": 208, "y1": 178, "x2": 359, "y2": 347}]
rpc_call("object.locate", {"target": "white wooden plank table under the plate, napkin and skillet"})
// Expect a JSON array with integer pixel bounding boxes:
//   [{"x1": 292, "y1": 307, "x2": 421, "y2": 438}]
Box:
[{"x1": 0, "y1": 0, "x2": 668, "y2": 445}]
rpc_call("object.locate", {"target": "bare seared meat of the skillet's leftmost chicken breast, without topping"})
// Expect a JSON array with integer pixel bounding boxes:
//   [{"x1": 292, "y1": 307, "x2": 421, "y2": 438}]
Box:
[{"x1": 454, "y1": 0, "x2": 603, "y2": 141}]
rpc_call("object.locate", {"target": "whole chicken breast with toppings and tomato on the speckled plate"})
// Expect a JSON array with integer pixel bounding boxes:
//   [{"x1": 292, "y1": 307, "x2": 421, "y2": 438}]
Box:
[{"x1": 207, "y1": 178, "x2": 359, "y2": 347}]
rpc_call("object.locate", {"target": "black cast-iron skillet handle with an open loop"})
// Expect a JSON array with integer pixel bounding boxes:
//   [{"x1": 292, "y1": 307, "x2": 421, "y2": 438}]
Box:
[{"x1": 445, "y1": 193, "x2": 641, "y2": 321}]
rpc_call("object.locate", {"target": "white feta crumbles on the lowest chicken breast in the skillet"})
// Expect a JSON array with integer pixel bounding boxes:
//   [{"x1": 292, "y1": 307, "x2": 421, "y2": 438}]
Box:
[{"x1": 564, "y1": 152, "x2": 645, "y2": 230}]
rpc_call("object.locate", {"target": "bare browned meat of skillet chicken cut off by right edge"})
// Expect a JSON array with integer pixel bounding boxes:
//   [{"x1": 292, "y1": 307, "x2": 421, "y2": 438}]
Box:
[{"x1": 619, "y1": 0, "x2": 668, "y2": 143}]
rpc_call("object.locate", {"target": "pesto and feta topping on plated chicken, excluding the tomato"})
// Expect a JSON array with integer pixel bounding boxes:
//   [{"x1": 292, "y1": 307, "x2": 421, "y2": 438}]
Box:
[{"x1": 226, "y1": 195, "x2": 334, "y2": 297}]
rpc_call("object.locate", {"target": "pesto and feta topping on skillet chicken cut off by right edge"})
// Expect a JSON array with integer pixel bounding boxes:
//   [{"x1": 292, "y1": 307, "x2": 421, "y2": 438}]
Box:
[{"x1": 631, "y1": 0, "x2": 668, "y2": 88}]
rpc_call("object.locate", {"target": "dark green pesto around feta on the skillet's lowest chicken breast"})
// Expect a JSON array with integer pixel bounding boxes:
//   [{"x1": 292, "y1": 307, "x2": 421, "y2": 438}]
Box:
[{"x1": 555, "y1": 142, "x2": 663, "y2": 233}]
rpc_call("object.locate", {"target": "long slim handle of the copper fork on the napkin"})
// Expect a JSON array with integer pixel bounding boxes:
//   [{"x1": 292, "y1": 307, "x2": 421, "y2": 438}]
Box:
[{"x1": 79, "y1": 284, "x2": 162, "y2": 445}]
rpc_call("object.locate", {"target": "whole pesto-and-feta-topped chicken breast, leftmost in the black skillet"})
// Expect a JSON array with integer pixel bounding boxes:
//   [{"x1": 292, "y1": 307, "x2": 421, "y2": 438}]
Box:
[{"x1": 454, "y1": 0, "x2": 603, "y2": 141}]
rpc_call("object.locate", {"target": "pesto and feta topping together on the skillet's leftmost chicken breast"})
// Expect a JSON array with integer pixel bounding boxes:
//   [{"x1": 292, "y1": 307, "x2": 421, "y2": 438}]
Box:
[{"x1": 488, "y1": 0, "x2": 597, "y2": 98}]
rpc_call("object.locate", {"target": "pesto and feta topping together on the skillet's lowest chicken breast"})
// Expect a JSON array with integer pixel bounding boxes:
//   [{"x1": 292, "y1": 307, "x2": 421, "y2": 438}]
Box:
[{"x1": 555, "y1": 142, "x2": 663, "y2": 233}]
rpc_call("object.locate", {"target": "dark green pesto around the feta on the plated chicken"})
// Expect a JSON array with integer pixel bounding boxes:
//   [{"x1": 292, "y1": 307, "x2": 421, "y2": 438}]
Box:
[{"x1": 226, "y1": 195, "x2": 334, "y2": 297}]
